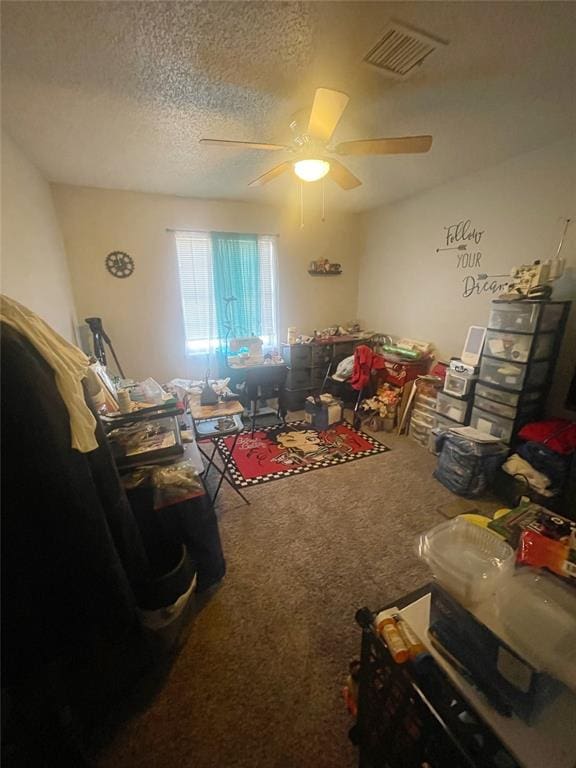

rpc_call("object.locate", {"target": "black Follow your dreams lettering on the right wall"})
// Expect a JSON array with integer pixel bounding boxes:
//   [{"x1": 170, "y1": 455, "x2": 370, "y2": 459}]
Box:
[{"x1": 436, "y1": 219, "x2": 507, "y2": 299}]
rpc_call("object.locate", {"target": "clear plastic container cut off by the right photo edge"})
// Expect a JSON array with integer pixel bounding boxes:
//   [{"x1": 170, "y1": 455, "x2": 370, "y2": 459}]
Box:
[{"x1": 496, "y1": 568, "x2": 576, "y2": 691}]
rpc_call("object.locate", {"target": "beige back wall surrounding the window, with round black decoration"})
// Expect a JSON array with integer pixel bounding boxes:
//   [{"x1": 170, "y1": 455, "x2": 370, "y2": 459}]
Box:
[{"x1": 53, "y1": 185, "x2": 359, "y2": 381}]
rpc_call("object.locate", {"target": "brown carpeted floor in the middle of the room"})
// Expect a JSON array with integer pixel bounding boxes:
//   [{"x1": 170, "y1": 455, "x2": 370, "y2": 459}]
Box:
[{"x1": 98, "y1": 416, "x2": 495, "y2": 768}]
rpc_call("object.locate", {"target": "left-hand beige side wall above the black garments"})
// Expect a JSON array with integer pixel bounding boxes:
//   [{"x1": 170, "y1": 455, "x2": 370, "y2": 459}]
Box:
[{"x1": 1, "y1": 132, "x2": 75, "y2": 340}]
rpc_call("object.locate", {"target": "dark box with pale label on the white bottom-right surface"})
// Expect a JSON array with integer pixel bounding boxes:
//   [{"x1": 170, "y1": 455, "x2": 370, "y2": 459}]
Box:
[{"x1": 429, "y1": 584, "x2": 564, "y2": 725}]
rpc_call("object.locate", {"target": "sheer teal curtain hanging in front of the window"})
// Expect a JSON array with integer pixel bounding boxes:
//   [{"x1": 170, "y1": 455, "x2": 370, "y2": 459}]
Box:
[{"x1": 211, "y1": 232, "x2": 262, "y2": 340}]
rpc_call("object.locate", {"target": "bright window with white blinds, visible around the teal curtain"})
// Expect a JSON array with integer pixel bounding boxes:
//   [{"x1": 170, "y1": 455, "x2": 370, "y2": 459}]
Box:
[{"x1": 176, "y1": 231, "x2": 278, "y2": 355}]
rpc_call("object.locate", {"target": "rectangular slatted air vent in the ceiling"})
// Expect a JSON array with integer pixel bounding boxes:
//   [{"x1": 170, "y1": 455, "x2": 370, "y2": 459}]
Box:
[{"x1": 364, "y1": 21, "x2": 448, "y2": 80}]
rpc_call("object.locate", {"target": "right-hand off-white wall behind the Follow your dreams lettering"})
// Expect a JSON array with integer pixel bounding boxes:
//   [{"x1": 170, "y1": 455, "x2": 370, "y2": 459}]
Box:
[{"x1": 358, "y1": 135, "x2": 576, "y2": 416}]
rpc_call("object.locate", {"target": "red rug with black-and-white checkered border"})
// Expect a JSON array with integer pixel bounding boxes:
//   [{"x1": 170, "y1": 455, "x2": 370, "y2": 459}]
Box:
[{"x1": 218, "y1": 421, "x2": 390, "y2": 488}]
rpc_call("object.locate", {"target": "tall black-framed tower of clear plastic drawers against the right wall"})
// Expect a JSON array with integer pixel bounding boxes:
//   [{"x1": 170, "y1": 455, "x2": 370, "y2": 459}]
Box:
[{"x1": 470, "y1": 299, "x2": 570, "y2": 444}]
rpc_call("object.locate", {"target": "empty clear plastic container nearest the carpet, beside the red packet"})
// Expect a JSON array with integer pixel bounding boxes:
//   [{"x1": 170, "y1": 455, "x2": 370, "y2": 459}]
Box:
[{"x1": 417, "y1": 517, "x2": 514, "y2": 606}]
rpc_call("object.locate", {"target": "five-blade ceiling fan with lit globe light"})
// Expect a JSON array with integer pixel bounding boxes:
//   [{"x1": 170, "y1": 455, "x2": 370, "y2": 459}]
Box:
[{"x1": 200, "y1": 88, "x2": 432, "y2": 190}]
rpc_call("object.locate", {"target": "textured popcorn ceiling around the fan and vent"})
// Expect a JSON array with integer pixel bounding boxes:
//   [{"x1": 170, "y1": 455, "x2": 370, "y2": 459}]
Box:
[{"x1": 1, "y1": 2, "x2": 576, "y2": 211}]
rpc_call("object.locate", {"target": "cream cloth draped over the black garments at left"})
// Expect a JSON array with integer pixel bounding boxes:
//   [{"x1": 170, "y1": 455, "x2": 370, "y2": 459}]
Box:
[{"x1": 0, "y1": 295, "x2": 98, "y2": 453}]
